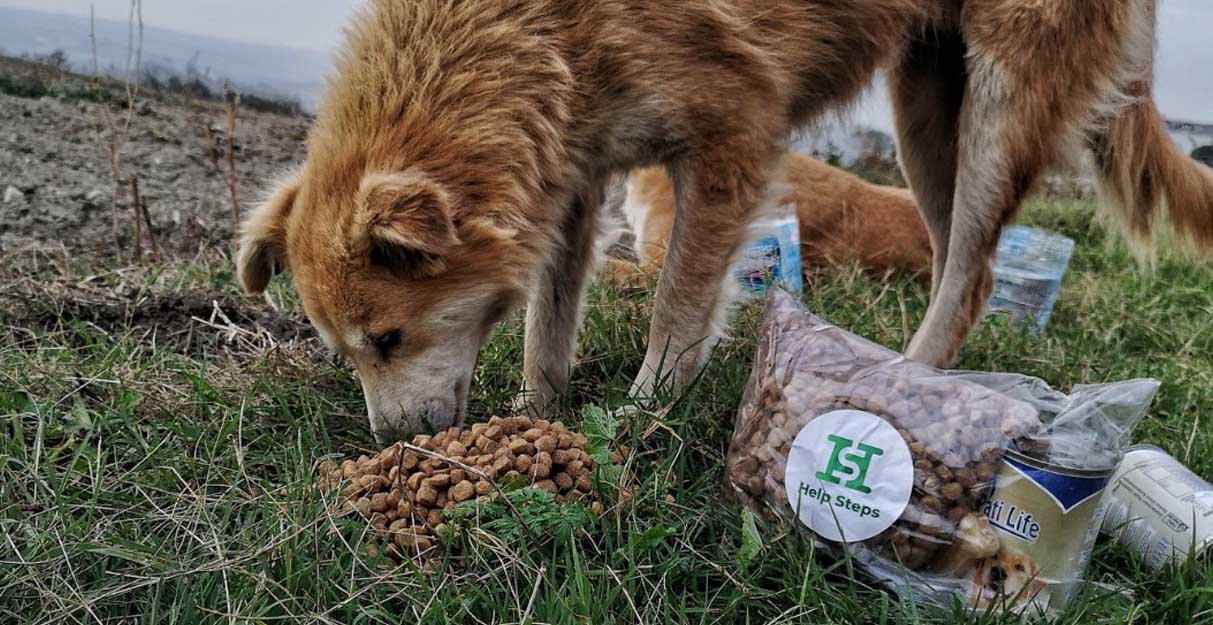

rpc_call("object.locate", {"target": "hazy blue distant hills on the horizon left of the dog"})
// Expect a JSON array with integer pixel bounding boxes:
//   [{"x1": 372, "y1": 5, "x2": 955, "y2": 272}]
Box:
[{"x1": 0, "y1": 7, "x2": 330, "y2": 108}]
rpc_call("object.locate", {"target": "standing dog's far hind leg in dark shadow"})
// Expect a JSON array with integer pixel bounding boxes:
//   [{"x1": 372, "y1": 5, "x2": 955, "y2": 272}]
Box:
[{"x1": 889, "y1": 30, "x2": 966, "y2": 299}]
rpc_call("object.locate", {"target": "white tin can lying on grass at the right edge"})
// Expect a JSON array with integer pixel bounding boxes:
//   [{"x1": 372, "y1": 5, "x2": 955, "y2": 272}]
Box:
[{"x1": 1103, "y1": 445, "x2": 1213, "y2": 568}]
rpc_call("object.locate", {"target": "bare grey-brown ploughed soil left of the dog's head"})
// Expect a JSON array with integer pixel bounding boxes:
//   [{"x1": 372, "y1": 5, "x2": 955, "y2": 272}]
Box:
[{"x1": 0, "y1": 56, "x2": 309, "y2": 256}]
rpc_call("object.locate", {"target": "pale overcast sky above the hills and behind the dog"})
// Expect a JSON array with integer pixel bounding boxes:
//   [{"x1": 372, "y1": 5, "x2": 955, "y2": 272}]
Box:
[{"x1": 0, "y1": 0, "x2": 1213, "y2": 129}]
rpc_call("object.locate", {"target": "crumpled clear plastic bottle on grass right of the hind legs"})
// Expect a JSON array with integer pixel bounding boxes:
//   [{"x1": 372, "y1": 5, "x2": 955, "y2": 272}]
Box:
[{"x1": 989, "y1": 226, "x2": 1074, "y2": 334}]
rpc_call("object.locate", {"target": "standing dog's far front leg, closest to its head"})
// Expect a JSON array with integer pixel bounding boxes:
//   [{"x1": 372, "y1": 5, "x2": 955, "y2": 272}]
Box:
[{"x1": 518, "y1": 182, "x2": 605, "y2": 414}]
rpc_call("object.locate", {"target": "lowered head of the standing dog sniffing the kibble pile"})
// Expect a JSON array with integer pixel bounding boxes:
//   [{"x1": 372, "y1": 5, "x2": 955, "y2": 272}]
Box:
[{"x1": 238, "y1": 169, "x2": 526, "y2": 441}]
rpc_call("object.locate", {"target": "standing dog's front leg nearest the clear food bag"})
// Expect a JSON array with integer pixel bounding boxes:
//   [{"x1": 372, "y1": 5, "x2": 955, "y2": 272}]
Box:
[{"x1": 632, "y1": 144, "x2": 782, "y2": 400}]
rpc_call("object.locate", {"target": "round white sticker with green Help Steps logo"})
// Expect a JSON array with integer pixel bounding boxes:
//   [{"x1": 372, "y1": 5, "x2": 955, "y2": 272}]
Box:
[{"x1": 784, "y1": 410, "x2": 913, "y2": 542}]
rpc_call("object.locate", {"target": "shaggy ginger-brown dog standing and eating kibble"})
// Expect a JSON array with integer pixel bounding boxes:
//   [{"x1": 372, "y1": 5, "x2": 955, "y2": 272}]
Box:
[{"x1": 238, "y1": 0, "x2": 1213, "y2": 438}]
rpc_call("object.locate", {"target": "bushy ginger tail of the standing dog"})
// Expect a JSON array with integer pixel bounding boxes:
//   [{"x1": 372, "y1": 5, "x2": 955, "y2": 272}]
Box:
[{"x1": 1092, "y1": 80, "x2": 1213, "y2": 256}]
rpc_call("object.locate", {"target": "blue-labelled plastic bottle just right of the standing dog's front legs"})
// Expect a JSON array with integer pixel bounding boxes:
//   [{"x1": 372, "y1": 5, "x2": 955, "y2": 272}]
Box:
[{"x1": 733, "y1": 204, "x2": 804, "y2": 297}]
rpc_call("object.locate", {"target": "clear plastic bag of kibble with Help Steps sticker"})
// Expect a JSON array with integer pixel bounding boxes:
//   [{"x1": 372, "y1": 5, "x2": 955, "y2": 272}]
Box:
[{"x1": 727, "y1": 290, "x2": 1156, "y2": 609}]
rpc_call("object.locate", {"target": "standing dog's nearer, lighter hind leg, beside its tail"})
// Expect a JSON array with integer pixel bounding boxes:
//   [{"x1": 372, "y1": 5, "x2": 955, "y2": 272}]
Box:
[{"x1": 907, "y1": 0, "x2": 1141, "y2": 367}]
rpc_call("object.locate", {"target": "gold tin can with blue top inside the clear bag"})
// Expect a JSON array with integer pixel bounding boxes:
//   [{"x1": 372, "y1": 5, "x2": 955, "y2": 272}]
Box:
[{"x1": 970, "y1": 451, "x2": 1115, "y2": 612}]
